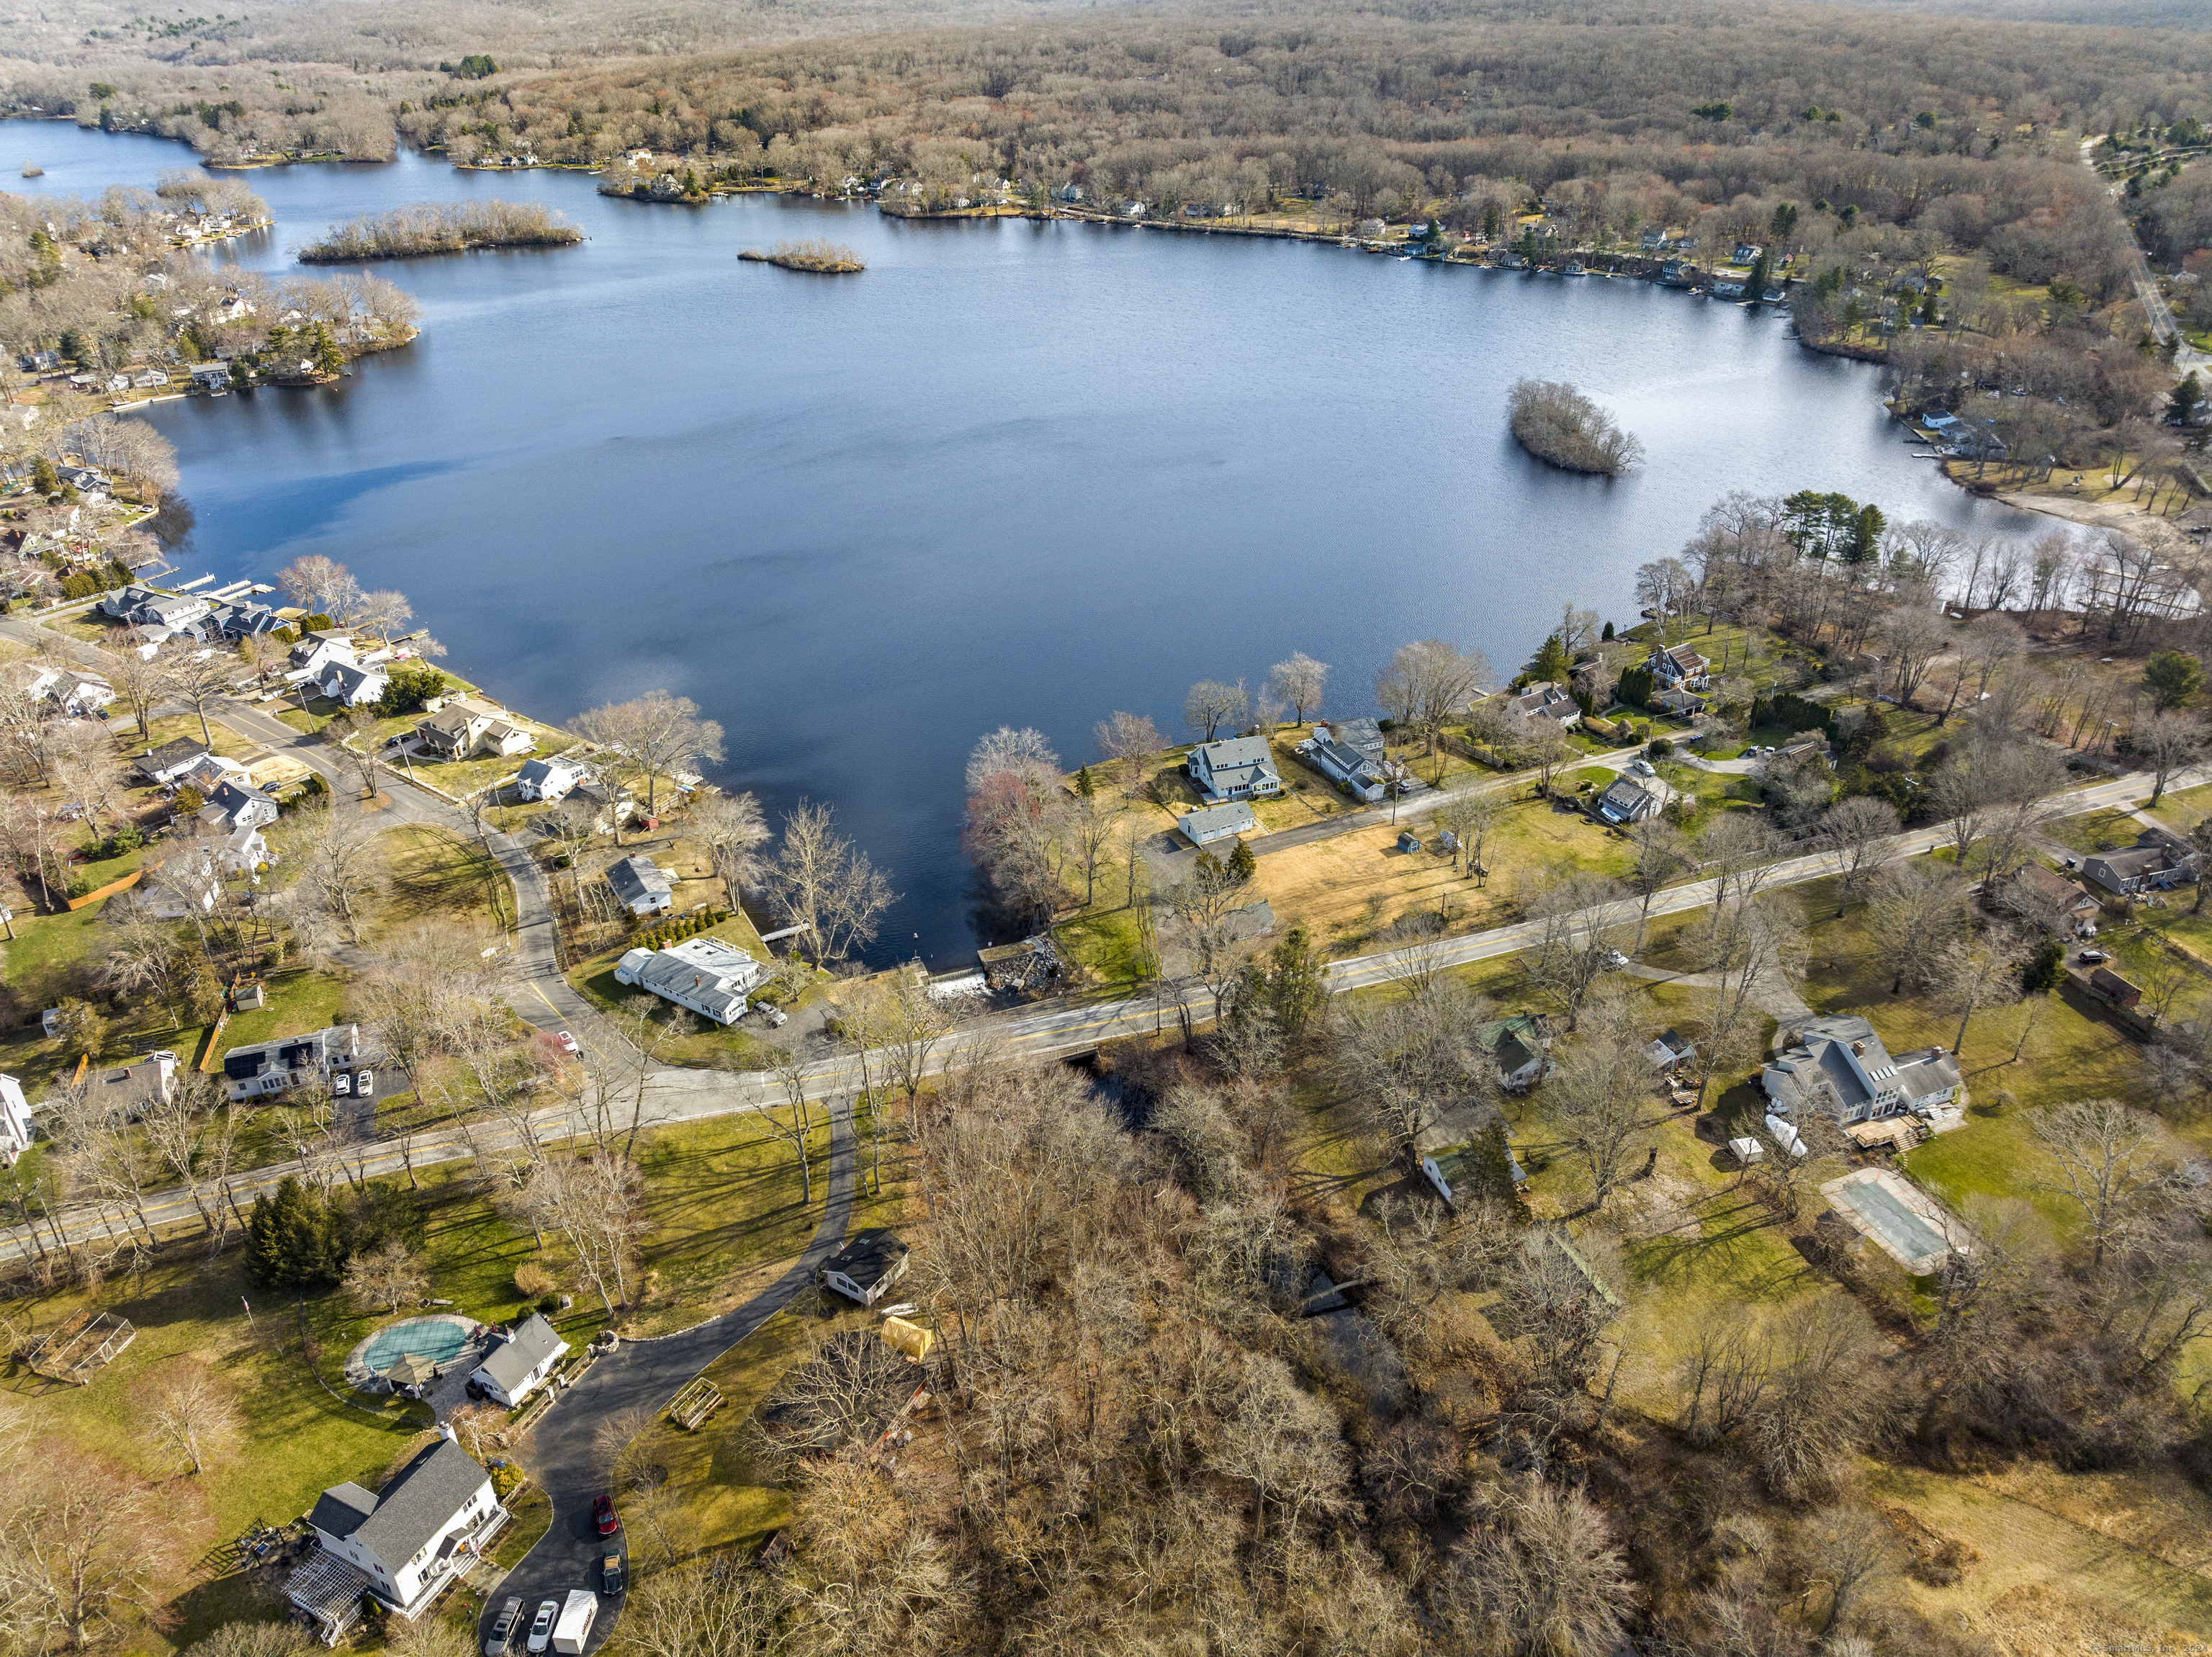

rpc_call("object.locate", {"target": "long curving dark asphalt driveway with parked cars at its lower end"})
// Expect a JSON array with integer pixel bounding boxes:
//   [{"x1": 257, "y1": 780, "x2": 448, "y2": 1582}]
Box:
[{"x1": 475, "y1": 1100, "x2": 858, "y2": 1653}]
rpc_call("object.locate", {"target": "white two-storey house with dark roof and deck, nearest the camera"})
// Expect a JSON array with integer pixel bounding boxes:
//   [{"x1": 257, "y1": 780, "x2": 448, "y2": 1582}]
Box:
[{"x1": 285, "y1": 1438, "x2": 506, "y2": 1644}]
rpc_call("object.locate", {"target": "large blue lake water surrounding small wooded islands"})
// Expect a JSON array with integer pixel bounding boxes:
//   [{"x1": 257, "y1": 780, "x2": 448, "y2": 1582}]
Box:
[{"x1": 0, "y1": 122, "x2": 2031, "y2": 964}]
